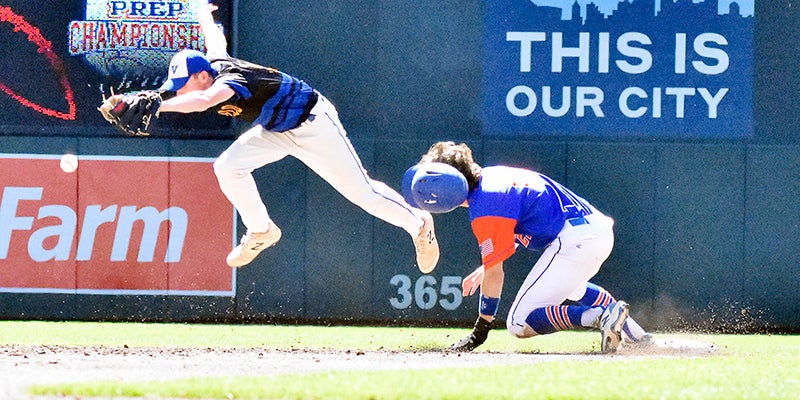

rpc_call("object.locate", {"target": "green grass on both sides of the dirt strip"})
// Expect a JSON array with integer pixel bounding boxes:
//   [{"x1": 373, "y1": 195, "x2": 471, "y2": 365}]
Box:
[{"x1": 0, "y1": 322, "x2": 800, "y2": 400}]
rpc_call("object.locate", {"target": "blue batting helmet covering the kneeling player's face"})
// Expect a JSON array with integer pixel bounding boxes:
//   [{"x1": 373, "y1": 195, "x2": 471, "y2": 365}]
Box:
[{"x1": 402, "y1": 162, "x2": 469, "y2": 214}]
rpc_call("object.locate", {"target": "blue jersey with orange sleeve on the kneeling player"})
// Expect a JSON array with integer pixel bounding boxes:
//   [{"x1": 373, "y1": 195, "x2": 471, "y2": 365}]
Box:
[{"x1": 467, "y1": 166, "x2": 594, "y2": 266}]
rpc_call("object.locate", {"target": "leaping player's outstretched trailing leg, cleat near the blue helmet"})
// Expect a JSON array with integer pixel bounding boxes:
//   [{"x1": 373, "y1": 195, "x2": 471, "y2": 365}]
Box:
[{"x1": 287, "y1": 96, "x2": 439, "y2": 273}]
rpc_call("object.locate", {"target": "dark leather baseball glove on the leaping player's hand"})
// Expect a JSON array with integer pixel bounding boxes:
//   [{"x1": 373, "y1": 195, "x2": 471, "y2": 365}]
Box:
[{"x1": 97, "y1": 90, "x2": 161, "y2": 136}]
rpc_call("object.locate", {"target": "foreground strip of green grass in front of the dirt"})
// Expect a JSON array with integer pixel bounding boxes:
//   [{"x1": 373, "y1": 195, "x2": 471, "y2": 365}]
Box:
[{"x1": 44, "y1": 359, "x2": 800, "y2": 399}]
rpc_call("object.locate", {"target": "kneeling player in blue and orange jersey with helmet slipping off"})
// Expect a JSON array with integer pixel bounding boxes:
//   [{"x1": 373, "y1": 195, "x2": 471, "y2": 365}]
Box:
[{"x1": 402, "y1": 142, "x2": 652, "y2": 353}]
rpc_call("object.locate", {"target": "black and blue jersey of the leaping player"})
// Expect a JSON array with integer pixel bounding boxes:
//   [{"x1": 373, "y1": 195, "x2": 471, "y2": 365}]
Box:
[{"x1": 210, "y1": 57, "x2": 318, "y2": 132}]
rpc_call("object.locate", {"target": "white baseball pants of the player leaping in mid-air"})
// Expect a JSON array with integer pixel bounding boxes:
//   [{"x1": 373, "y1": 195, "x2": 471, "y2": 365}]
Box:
[{"x1": 214, "y1": 94, "x2": 423, "y2": 237}]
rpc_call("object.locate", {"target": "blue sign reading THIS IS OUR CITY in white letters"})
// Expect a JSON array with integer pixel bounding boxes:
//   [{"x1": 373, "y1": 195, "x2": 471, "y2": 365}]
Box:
[{"x1": 483, "y1": 0, "x2": 754, "y2": 138}]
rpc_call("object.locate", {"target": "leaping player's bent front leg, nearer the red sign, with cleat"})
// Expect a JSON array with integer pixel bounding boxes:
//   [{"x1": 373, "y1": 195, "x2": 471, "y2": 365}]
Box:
[{"x1": 214, "y1": 127, "x2": 294, "y2": 267}]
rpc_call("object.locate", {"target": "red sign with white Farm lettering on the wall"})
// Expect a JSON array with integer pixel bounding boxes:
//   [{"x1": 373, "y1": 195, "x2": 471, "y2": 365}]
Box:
[{"x1": 0, "y1": 154, "x2": 236, "y2": 296}]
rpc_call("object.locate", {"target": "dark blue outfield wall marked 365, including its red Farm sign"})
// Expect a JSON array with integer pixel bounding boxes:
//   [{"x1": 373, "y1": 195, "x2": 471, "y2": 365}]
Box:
[{"x1": 0, "y1": 1, "x2": 800, "y2": 330}]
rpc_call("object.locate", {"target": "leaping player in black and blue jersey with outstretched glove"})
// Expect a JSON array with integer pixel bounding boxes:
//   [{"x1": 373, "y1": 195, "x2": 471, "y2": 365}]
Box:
[{"x1": 100, "y1": 4, "x2": 439, "y2": 273}]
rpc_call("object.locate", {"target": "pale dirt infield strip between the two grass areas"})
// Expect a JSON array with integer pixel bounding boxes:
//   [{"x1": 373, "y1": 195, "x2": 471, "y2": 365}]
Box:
[{"x1": 0, "y1": 340, "x2": 718, "y2": 399}]
